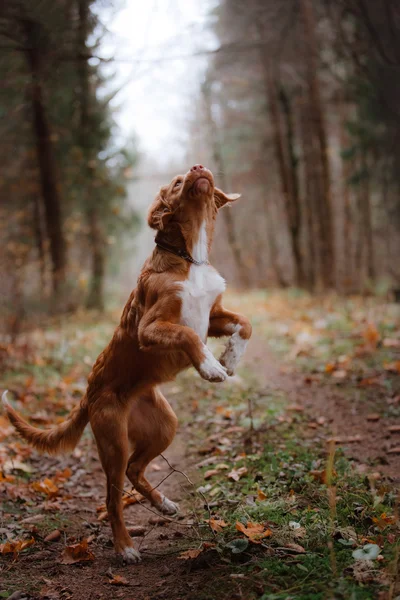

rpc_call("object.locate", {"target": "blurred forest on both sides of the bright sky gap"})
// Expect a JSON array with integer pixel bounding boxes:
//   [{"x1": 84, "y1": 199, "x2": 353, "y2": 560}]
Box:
[{"x1": 0, "y1": 0, "x2": 400, "y2": 335}]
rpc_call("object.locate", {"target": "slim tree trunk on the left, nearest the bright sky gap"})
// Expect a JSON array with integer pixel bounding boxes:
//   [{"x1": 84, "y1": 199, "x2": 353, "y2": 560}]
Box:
[{"x1": 77, "y1": 0, "x2": 106, "y2": 310}]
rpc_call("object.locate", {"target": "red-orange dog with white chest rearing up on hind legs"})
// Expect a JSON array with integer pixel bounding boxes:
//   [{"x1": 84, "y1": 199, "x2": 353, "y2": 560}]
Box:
[{"x1": 3, "y1": 165, "x2": 251, "y2": 563}]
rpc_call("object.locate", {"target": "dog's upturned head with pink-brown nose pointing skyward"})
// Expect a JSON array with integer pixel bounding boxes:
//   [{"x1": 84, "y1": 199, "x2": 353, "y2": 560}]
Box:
[{"x1": 148, "y1": 165, "x2": 240, "y2": 242}]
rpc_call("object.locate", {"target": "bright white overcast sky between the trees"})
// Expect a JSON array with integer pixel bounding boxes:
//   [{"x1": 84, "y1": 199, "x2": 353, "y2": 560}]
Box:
[{"x1": 97, "y1": 0, "x2": 217, "y2": 164}]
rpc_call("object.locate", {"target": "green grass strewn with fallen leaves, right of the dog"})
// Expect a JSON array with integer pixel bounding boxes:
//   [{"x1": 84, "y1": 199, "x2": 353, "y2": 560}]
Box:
[{"x1": 182, "y1": 374, "x2": 399, "y2": 600}]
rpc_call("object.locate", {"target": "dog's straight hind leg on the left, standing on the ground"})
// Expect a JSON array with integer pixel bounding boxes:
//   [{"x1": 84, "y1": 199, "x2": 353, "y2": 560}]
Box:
[{"x1": 90, "y1": 398, "x2": 140, "y2": 563}]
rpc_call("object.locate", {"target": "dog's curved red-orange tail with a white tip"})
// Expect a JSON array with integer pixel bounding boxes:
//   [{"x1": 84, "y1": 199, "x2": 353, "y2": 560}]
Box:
[{"x1": 1, "y1": 390, "x2": 89, "y2": 454}]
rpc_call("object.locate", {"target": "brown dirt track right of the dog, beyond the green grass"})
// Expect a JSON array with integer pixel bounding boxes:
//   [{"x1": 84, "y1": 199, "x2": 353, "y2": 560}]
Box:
[{"x1": 246, "y1": 336, "x2": 400, "y2": 484}]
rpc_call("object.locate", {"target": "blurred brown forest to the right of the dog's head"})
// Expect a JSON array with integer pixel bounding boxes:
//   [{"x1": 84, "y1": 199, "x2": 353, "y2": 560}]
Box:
[{"x1": 191, "y1": 0, "x2": 400, "y2": 293}]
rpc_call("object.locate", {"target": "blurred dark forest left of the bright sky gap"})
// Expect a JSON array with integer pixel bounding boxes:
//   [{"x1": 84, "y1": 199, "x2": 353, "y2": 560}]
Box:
[{"x1": 0, "y1": 0, "x2": 137, "y2": 335}]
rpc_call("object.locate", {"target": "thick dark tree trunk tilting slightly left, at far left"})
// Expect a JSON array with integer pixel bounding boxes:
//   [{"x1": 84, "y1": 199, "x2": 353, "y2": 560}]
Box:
[{"x1": 23, "y1": 20, "x2": 66, "y2": 292}]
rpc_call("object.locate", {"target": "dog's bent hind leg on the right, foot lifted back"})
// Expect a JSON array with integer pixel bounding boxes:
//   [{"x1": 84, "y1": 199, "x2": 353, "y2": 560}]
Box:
[{"x1": 126, "y1": 388, "x2": 178, "y2": 515}]
